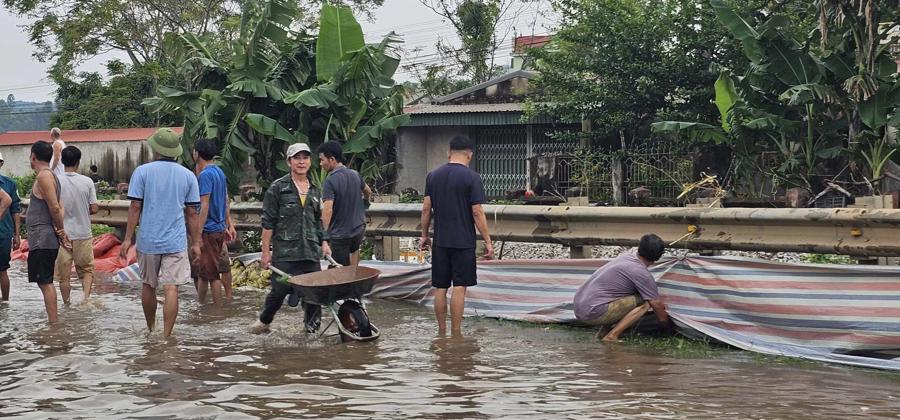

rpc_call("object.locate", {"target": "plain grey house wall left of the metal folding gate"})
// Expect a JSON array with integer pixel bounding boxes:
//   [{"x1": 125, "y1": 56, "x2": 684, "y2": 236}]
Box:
[{"x1": 396, "y1": 126, "x2": 475, "y2": 194}]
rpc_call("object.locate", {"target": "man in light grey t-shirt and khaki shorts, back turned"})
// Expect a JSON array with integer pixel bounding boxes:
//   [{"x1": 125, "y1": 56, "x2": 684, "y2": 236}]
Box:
[{"x1": 53, "y1": 146, "x2": 99, "y2": 305}]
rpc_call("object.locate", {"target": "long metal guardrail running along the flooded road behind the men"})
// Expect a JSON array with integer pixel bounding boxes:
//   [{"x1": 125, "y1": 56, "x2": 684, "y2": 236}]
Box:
[{"x1": 23, "y1": 200, "x2": 900, "y2": 256}]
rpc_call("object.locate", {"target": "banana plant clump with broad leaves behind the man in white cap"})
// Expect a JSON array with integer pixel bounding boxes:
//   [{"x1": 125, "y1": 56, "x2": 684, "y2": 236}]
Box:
[{"x1": 144, "y1": 0, "x2": 409, "y2": 187}]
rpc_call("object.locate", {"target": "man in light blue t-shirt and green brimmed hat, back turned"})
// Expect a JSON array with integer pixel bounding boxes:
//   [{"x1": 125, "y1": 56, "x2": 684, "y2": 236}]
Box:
[{"x1": 120, "y1": 128, "x2": 201, "y2": 337}]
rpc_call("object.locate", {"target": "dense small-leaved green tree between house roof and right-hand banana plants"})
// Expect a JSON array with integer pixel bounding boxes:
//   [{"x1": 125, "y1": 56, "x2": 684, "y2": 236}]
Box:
[{"x1": 529, "y1": 0, "x2": 743, "y2": 144}]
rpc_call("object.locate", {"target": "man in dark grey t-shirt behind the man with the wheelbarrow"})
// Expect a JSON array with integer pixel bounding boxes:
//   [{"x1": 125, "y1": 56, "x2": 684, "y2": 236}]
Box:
[{"x1": 319, "y1": 141, "x2": 372, "y2": 265}]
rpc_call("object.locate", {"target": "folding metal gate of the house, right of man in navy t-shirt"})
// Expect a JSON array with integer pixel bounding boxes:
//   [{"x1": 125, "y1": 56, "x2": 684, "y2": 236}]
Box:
[{"x1": 472, "y1": 125, "x2": 528, "y2": 198}]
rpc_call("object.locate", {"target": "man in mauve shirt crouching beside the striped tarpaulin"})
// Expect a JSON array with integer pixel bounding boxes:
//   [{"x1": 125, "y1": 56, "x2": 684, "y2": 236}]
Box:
[{"x1": 575, "y1": 233, "x2": 671, "y2": 341}]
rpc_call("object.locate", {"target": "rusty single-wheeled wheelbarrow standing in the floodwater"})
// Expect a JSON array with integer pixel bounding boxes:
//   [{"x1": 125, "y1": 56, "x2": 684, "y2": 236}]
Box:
[{"x1": 271, "y1": 258, "x2": 381, "y2": 342}]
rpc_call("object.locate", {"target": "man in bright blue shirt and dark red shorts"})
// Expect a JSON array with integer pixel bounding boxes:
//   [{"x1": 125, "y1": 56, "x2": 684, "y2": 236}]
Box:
[{"x1": 191, "y1": 139, "x2": 236, "y2": 304}]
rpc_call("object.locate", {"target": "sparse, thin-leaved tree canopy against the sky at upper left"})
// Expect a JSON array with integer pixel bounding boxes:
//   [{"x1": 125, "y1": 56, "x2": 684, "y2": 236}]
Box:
[{"x1": 3, "y1": 0, "x2": 383, "y2": 79}]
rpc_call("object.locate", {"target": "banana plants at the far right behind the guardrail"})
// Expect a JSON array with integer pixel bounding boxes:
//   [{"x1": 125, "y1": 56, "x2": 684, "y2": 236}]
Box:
[{"x1": 654, "y1": 0, "x2": 900, "y2": 195}]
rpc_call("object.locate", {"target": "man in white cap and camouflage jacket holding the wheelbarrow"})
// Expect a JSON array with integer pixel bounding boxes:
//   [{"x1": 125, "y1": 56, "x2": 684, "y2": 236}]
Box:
[{"x1": 250, "y1": 143, "x2": 331, "y2": 334}]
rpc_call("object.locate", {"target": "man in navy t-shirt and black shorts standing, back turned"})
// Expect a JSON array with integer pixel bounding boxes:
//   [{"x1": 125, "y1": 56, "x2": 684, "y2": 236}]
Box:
[{"x1": 419, "y1": 136, "x2": 494, "y2": 334}]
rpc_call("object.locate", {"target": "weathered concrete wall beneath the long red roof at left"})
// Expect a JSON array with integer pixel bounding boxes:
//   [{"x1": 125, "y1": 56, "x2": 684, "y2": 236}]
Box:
[{"x1": 0, "y1": 140, "x2": 152, "y2": 185}]
